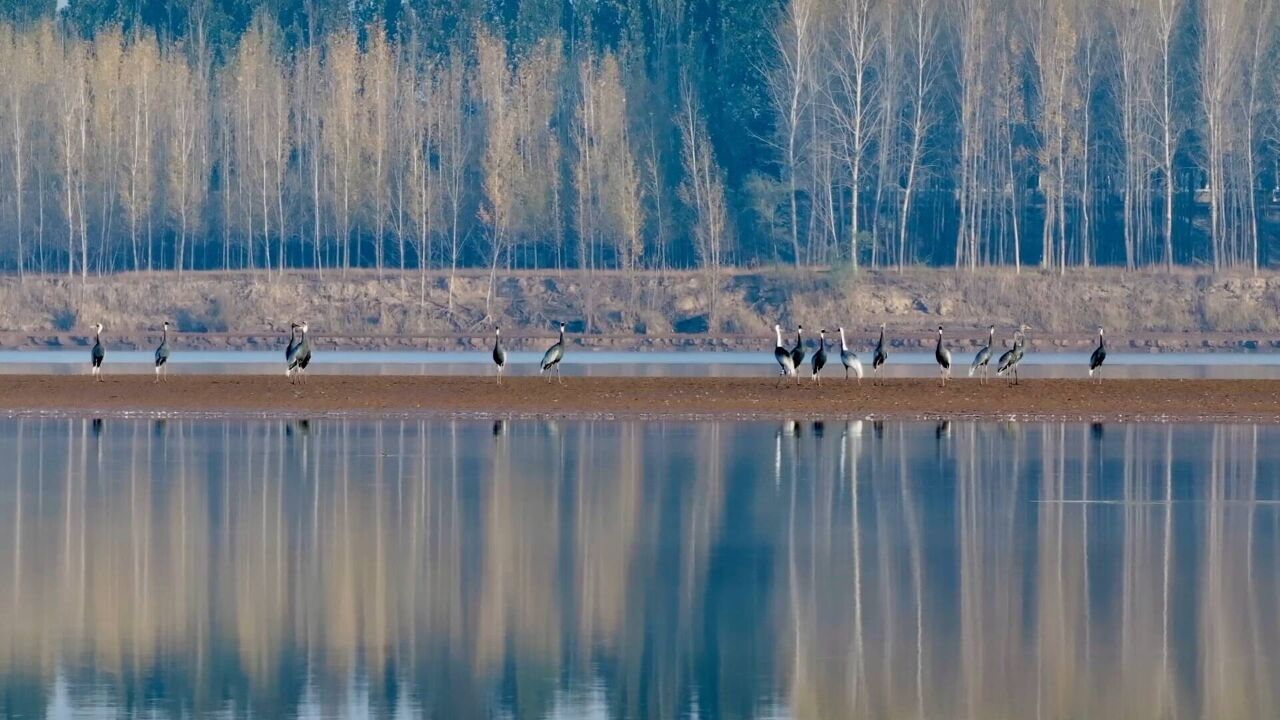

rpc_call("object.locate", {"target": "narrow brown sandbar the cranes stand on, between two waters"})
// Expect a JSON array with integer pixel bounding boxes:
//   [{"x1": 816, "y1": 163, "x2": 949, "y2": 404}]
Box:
[{"x1": 0, "y1": 374, "x2": 1280, "y2": 423}]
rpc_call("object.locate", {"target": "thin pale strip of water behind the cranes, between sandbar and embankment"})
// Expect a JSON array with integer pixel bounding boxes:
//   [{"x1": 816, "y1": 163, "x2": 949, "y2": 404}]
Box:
[{"x1": 0, "y1": 347, "x2": 1280, "y2": 379}]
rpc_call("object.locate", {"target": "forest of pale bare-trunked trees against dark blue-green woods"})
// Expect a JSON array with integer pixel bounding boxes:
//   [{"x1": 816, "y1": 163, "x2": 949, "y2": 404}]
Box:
[{"x1": 0, "y1": 0, "x2": 1280, "y2": 277}]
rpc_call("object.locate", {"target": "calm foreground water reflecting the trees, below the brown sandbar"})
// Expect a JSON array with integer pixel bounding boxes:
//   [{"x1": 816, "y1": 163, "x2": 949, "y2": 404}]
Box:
[{"x1": 0, "y1": 419, "x2": 1280, "y2": 719}]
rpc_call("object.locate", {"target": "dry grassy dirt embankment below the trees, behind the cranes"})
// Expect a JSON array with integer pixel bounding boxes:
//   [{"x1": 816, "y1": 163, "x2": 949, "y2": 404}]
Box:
[{"x1": 0, "y1": 269, "x2": 1280, "y2": 350}]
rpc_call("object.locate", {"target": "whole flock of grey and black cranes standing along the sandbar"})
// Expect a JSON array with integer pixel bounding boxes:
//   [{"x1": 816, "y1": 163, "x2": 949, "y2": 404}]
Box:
[{"x1": 80, "y1": 320, "x2": 1107, "y2": 387}]
